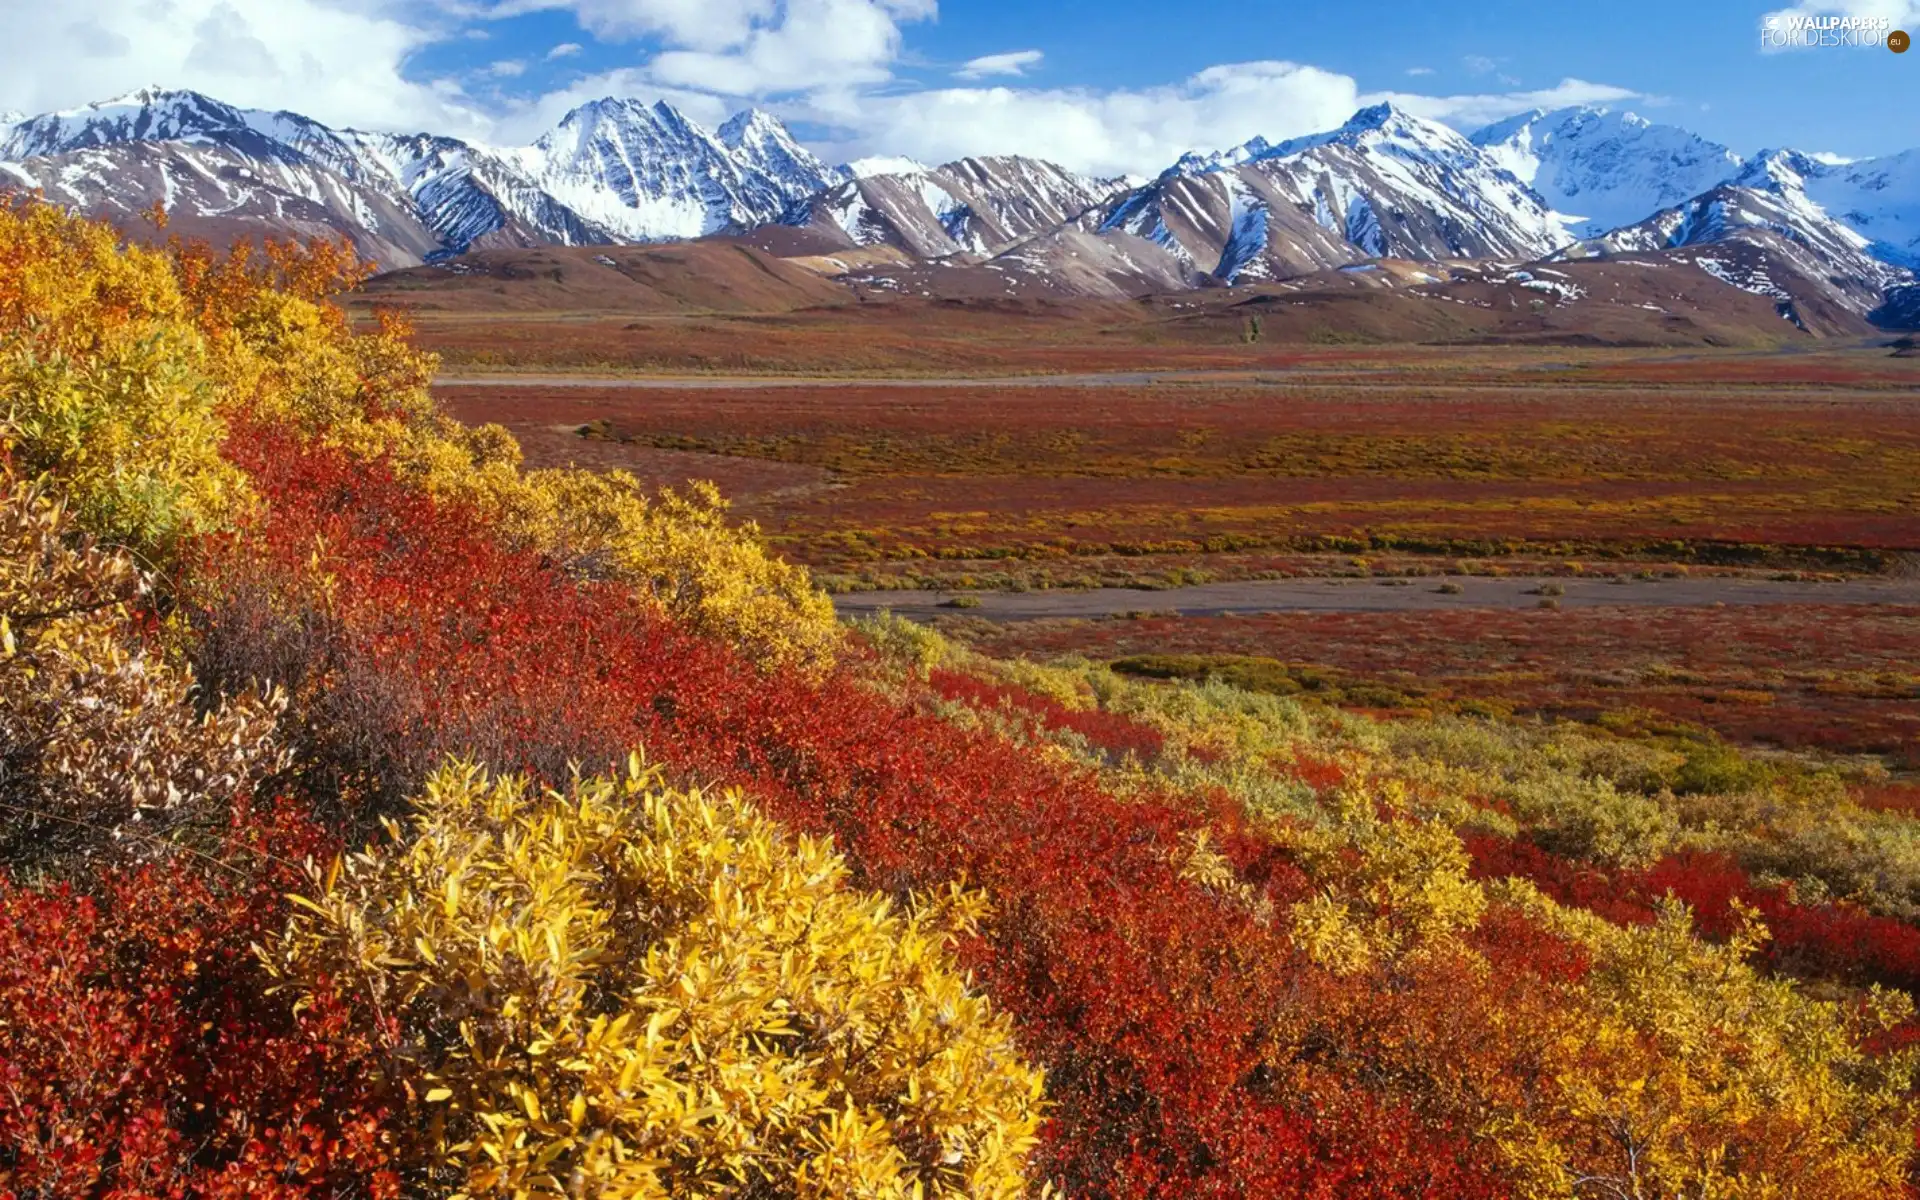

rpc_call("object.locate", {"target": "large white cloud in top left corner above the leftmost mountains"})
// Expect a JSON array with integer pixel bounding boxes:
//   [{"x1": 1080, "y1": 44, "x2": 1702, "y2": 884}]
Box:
[{"x1": 0, "y1": 0, "x2": 486, "y2": 132}]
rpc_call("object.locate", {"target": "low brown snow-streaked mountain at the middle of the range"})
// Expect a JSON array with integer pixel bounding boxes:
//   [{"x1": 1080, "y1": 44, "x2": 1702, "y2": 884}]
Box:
[{"x1": 785, "y1": 156, "x2": 1108, "y2": 259}]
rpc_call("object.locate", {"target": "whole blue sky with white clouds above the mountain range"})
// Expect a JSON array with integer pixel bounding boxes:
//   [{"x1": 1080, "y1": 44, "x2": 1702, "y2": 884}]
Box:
[{"x1": 0, "y1": 0, "x2": 1920, "y2": 173}]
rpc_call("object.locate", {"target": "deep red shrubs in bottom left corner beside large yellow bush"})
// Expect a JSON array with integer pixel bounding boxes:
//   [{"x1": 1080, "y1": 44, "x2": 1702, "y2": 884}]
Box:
[{"x1": 0, "y1": 798, "x2": 397, "y2": 1200}]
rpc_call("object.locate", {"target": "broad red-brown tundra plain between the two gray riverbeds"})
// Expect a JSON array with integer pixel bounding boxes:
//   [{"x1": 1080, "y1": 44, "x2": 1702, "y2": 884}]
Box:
[{"x1": 442, "y1": 376, "x2": 1920, "y2": 568}]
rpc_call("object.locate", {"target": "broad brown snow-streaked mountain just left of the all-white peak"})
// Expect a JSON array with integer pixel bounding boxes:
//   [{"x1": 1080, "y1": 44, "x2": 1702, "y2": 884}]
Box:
[{"x1": 1098, "y1": 104, "x2": 1569, "y2": 282}]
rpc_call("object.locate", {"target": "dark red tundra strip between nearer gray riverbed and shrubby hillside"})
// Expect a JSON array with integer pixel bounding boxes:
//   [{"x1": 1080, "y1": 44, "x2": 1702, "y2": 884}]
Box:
[{"x1": 966, "y1": 605, "x2": 1920, "y2": 756}]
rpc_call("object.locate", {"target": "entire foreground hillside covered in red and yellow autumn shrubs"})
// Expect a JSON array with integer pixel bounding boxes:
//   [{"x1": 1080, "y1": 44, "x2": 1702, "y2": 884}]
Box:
[{"x1": 0, "y1": 205, "x2": 1920, "y2": 1200}]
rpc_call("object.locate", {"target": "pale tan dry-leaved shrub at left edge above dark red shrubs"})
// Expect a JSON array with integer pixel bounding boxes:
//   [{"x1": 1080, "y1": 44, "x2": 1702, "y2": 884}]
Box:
[{"x1": 0, "y1": 465, "x2": 282, "y2": 874}]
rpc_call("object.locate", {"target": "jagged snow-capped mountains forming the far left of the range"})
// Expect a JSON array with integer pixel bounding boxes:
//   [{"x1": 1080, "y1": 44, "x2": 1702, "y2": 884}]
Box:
[{"x1": 0, "y1": 88, "x2": 839, "y2": 267}]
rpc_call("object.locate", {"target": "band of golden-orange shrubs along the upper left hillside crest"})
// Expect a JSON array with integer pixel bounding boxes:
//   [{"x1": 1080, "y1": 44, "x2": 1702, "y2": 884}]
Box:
[{"x1": 0, "y1": 202, "x2": 839, "y2": 668}]
